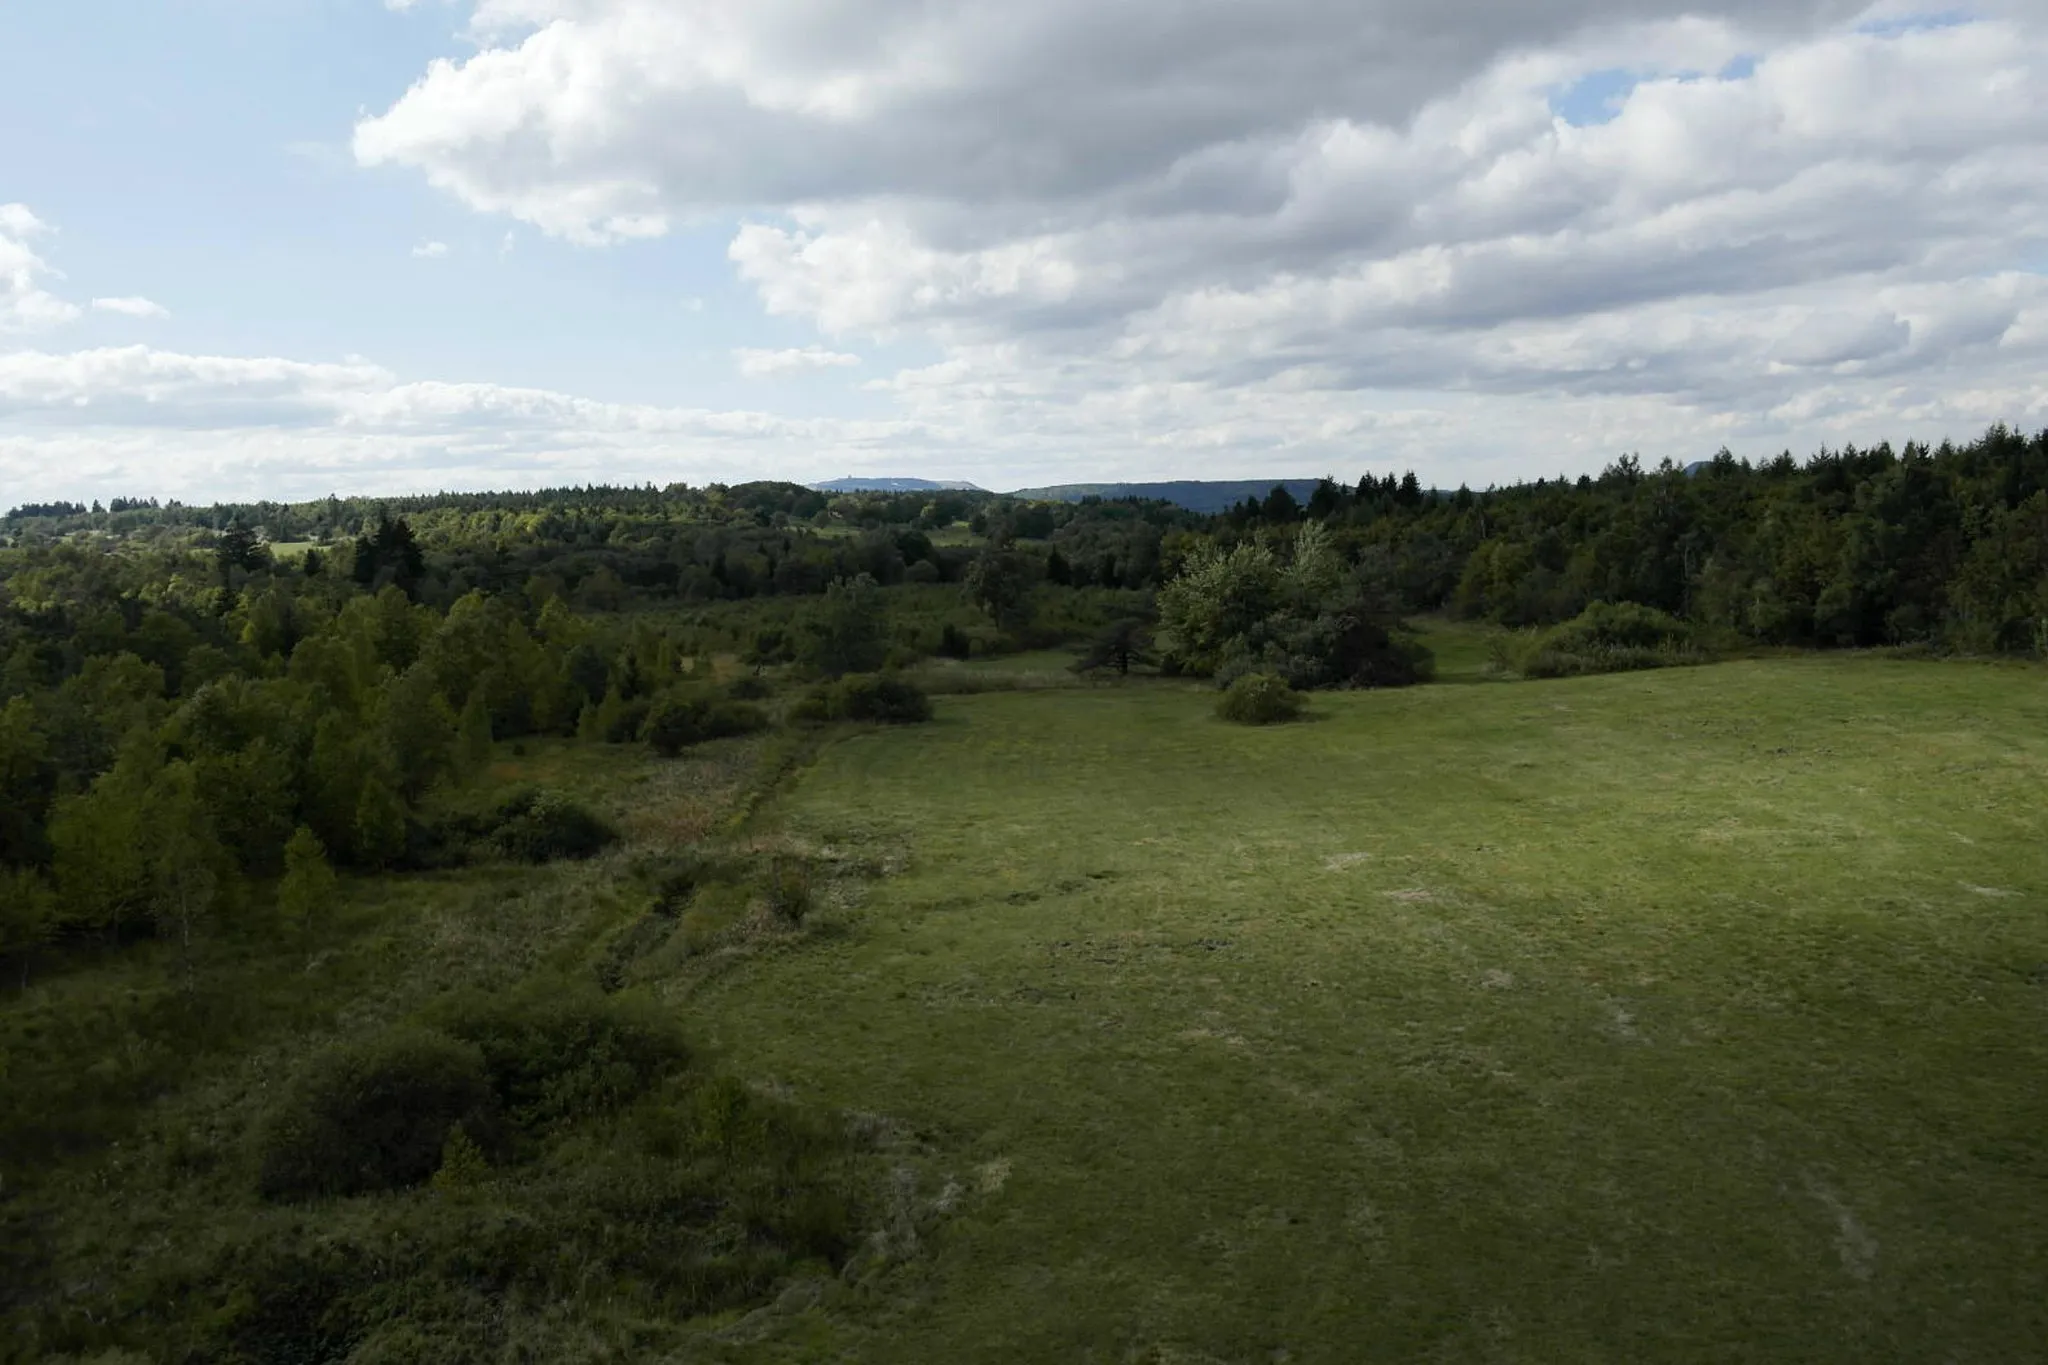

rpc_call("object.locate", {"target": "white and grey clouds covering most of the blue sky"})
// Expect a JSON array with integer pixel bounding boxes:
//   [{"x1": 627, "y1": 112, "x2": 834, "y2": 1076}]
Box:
[{"x1": 0, "y1": 0, "x2": 2048, "y2": 501}]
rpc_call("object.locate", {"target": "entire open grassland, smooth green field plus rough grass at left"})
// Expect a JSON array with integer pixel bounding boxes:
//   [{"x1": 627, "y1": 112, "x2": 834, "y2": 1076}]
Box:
[{"x1": 0, "y1": 646, "x2": 2048, "y2": 1365}]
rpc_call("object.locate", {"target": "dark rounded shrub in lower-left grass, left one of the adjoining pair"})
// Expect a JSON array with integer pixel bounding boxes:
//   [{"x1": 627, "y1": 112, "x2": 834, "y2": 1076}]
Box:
[{"x1": 258, "y1": 1029, "x2": 494, "y2": 1199}]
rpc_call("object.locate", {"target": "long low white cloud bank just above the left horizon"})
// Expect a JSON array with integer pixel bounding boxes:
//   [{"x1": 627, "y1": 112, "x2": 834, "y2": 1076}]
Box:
[{"x1": 0, "y1": 346, "x2": 932, "y2": 501}]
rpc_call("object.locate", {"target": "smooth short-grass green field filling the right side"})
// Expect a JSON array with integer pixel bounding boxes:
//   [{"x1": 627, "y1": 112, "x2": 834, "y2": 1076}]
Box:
[{"x1": 694, "y1": 657, "x2": 2048, "y2": 1361}]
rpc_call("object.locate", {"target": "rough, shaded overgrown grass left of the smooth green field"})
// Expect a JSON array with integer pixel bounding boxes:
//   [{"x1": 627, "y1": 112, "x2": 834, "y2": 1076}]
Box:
[{"x1": 0, "y1": 735, "x2": 901, "y2": 1363}]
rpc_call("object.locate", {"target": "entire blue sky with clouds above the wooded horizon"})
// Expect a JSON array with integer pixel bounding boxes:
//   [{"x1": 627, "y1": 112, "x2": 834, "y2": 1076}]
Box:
[{"x1": 0, "y1": 0, "x2": 2048, "y2": 508}]
